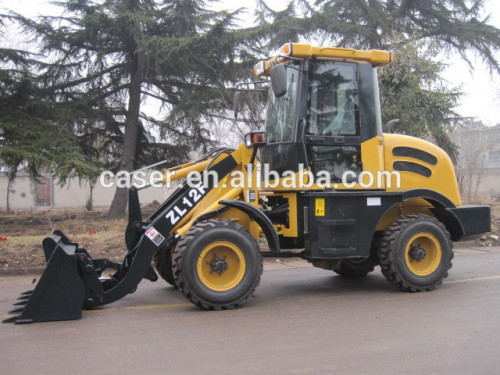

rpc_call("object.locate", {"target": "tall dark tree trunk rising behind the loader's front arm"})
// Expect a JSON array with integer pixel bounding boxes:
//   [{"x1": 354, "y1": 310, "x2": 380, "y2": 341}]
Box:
[{"x1": 108, "y1": 52, "x2": 145, "y2": 219}]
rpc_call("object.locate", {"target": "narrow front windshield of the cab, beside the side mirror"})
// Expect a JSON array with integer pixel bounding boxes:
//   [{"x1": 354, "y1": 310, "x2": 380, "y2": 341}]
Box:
[{"x1": 266, "y1": 68, "x2": 299, "y2": 143}]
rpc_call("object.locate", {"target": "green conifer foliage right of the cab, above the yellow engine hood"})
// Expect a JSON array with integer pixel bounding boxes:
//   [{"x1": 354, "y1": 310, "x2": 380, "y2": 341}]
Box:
[{"x1": 379, "y1": 44, "x2": 461, "y2": 161}]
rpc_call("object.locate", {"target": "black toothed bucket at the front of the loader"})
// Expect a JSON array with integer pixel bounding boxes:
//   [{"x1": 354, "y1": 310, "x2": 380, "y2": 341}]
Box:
[{"x1": 4, "y1": 232, "x2": 85, "y2": 324}]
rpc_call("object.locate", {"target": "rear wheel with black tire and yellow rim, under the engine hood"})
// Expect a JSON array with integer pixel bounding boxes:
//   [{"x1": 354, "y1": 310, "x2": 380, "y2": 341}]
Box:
[{"x1": 378, "y1": 215, "x2": 454, "y2": 292}]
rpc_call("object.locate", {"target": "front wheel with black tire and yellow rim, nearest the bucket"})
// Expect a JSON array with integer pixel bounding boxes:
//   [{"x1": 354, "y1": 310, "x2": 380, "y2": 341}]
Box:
[{"x1": 173, "y1": 220, "x2": 262, "y2": 310}]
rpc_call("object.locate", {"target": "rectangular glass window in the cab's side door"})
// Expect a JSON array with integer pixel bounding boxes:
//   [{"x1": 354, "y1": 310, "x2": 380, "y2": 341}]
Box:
[{"x1": 308, "y1": 61, "x2": 359, "y2": 136}]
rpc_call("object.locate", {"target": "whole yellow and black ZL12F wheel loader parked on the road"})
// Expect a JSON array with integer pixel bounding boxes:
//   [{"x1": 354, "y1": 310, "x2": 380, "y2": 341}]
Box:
[{"x1": 1, "y1": 43, "x2": 490, "y2": 324}]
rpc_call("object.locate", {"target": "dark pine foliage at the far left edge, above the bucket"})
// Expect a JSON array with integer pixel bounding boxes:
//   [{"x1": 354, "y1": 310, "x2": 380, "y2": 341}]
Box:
[{"x1": 0, "y1": 15, "x2": 95, "y2": 210}]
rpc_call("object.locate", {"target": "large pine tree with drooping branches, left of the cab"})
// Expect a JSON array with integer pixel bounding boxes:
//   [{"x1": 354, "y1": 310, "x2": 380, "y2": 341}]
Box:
[{"x1": 10, "y1": 0, "x2": 254, "y2": 217}]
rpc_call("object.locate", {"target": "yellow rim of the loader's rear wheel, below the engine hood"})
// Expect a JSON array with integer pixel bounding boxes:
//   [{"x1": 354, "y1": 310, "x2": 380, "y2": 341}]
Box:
[{"x1": 405, "y1": 233, "x2": 442, "y2": 276}]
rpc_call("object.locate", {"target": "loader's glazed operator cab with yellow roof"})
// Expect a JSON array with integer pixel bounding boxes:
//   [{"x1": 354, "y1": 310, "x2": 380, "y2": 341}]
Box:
[{"x1": 255, "y1": 44, "x2": 393, "y2": 189}]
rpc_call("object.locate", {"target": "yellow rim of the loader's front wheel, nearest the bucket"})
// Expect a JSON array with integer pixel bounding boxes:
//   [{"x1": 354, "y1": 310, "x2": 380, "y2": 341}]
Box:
[{"x1": 198, "y1": 241, "x2": 245, "y2": 292}]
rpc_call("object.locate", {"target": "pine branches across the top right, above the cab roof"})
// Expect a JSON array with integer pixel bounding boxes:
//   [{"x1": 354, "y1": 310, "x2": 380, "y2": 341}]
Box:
[{"x1": 311, "y1": 0, "x2": 500, "y2": 67}]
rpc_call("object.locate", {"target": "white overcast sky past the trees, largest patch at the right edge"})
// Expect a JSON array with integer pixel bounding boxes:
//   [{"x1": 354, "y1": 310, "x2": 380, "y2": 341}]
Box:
[{"x1": 0, "y1": 0, "x2": 500, "y2": 126}]
